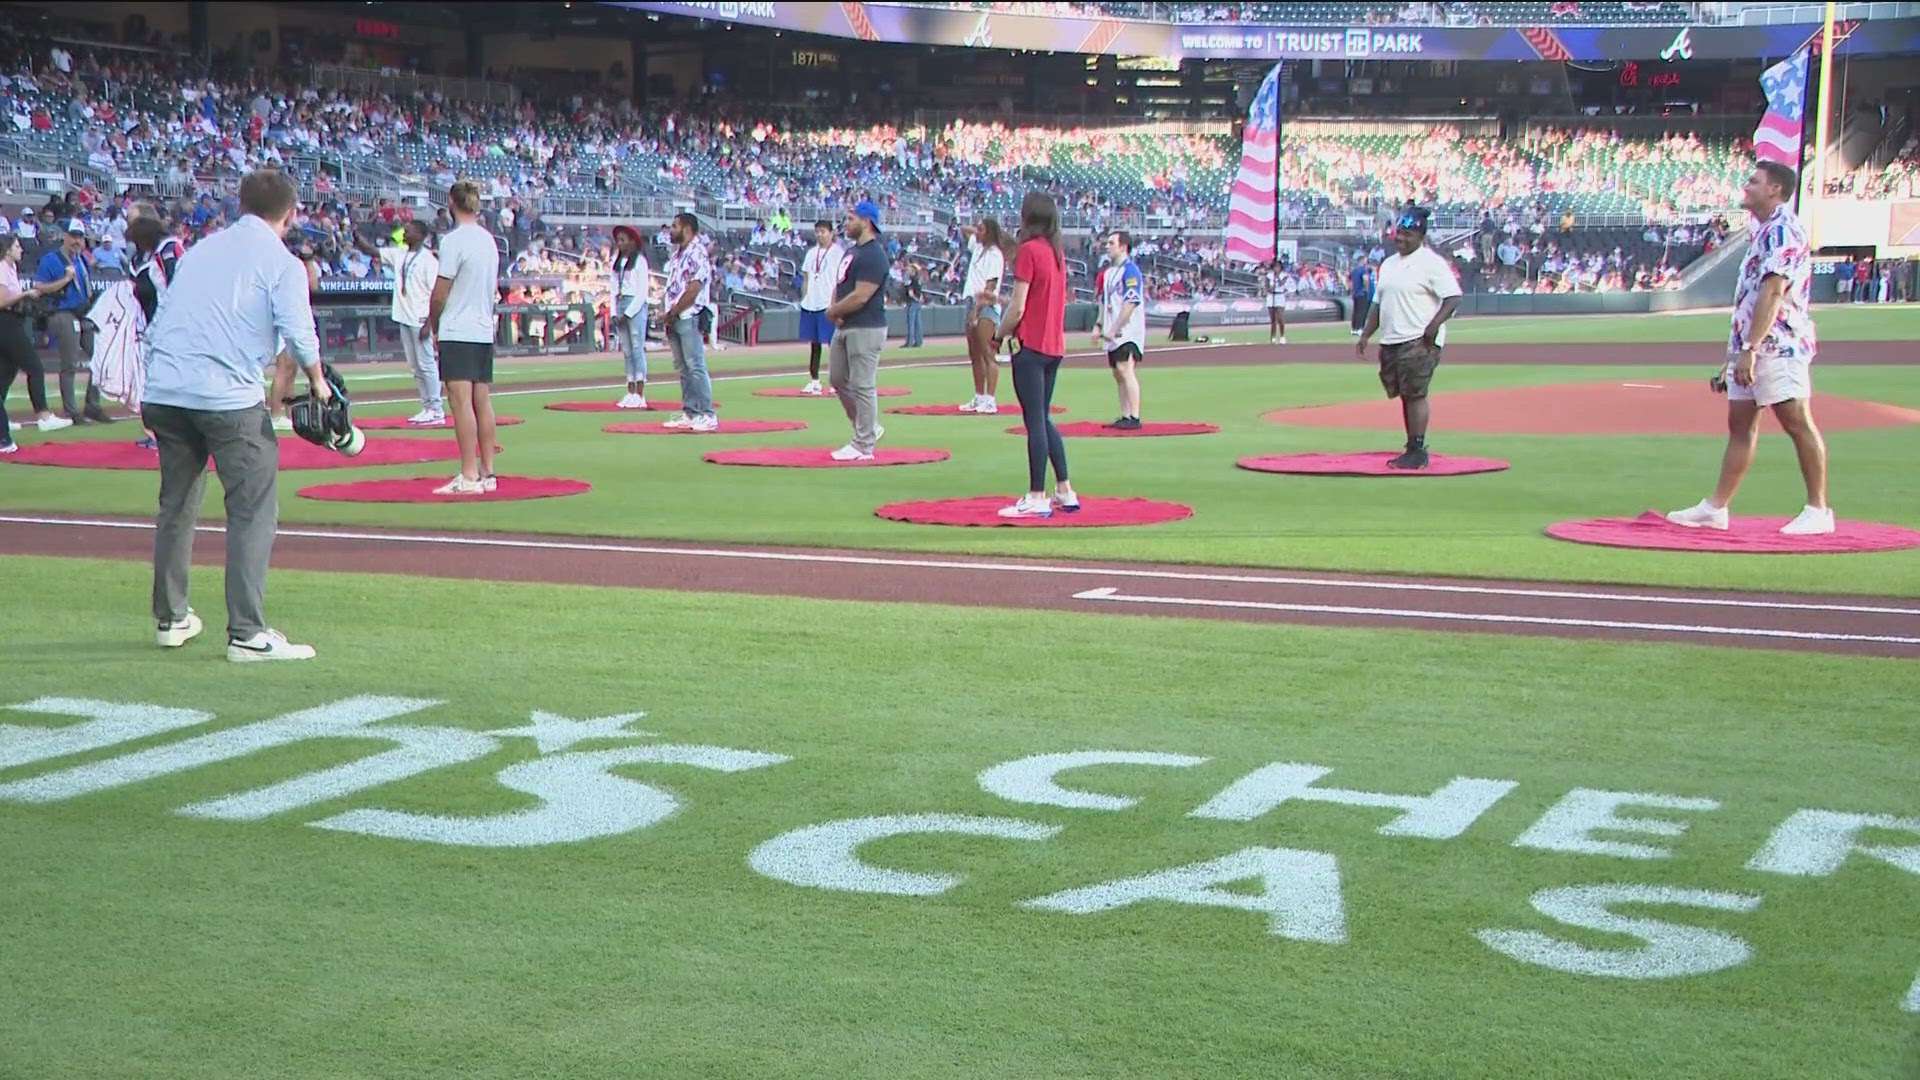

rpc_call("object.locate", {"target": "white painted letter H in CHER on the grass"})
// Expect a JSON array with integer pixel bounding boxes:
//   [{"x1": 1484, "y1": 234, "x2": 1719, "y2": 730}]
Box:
[{"x1": 1188, "y1": 763, "x2": 1519, "y2": 840}]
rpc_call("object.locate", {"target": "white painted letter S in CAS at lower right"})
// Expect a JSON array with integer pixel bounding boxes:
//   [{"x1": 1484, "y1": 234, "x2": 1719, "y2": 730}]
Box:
[{"x1": 1475, "y1": 886, "x2": 1761, "y2": 978}]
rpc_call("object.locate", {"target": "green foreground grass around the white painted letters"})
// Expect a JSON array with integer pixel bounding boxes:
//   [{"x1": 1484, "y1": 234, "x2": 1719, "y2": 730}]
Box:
[{"x1": 0, "y1": 559, "x2": 1920, "y2": 1080}]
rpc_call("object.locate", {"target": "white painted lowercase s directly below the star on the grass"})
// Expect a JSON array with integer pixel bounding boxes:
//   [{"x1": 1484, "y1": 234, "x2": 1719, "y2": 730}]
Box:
[{"x1": 313, "y1": 744, "x2": 789, "y2": 847}]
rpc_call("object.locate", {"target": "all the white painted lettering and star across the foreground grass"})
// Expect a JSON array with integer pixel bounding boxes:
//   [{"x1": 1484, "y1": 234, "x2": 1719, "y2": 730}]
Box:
[{"x1": 0, "y1": 696, "x2": 1920, "y2": 1013}]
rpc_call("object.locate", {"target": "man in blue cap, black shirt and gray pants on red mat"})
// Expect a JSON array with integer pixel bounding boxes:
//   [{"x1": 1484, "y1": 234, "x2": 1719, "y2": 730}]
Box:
[{"x1": 828, "y1": 200, "x2": 887, "y2": 461}]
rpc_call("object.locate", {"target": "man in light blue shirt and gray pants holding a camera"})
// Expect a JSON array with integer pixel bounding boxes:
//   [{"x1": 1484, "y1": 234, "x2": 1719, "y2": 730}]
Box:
[{"x1": 142, "y1": 169, "x2": 330, "y2": 663}]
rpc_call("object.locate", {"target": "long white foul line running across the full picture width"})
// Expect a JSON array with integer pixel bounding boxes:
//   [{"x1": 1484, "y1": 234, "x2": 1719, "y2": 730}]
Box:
[{"x1": 0, "y1": 515, "x2": 1920, "y2": 615}]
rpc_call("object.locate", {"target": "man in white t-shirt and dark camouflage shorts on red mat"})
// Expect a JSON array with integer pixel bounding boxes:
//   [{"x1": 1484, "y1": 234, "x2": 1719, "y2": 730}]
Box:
[{"x1": 1354, "y1": 208, "x2": 1459, "y2": 469}]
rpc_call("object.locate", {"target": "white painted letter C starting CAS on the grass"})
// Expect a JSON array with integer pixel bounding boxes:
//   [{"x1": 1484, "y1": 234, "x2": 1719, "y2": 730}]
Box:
[{"x1": 747, "y1": 813, "x2": 1060, "y2": 896}]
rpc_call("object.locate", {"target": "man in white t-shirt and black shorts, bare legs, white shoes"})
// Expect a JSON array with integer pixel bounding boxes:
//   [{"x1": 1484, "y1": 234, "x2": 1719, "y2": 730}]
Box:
[{"x1": 426, "y1": 181, "x2": 499, "y2": 496}]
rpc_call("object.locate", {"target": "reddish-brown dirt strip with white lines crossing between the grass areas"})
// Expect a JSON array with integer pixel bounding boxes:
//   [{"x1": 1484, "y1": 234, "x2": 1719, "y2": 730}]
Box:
[{"x1": 0, "y1": 515, "x2": 1920, "y2": 657}]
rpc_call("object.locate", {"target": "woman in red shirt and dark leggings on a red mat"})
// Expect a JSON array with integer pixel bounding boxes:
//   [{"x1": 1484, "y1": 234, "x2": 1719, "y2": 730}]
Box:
[{"x1": 1000, "y1": 192, "x2": 1079, "y2": 517}]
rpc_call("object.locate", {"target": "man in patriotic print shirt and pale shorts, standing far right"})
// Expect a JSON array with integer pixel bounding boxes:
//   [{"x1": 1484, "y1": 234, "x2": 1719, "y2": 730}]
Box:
[{"x1": 1667, "y1": 161, "x2": 1834, "y2": 536}]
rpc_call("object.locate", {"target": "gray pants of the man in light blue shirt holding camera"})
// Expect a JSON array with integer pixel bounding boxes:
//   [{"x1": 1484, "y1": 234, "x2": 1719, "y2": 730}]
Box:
[{"x1": 140, "y1": 404, "x2": 280, "y2": 640}]
